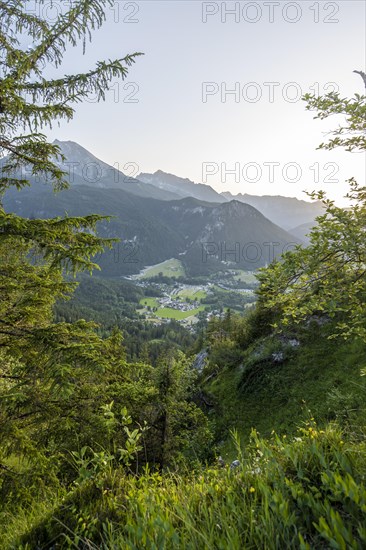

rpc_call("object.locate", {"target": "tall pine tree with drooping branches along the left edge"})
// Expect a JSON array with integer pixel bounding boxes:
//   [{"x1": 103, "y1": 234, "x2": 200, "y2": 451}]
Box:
[{"x1": 0, "y1": 0, "x2": 140, "y2": 471}]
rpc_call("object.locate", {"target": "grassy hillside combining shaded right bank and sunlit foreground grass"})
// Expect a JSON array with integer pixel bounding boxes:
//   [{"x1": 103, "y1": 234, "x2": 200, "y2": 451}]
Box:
[{"x1": 0, "y1": 329, "x2": 366, "y2": 550}]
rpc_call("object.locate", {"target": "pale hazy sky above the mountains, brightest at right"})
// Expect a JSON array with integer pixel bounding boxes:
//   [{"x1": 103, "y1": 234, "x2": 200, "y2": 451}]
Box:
[{"x1": 43, "y1": 0, "x2": 366, "y2": 202}]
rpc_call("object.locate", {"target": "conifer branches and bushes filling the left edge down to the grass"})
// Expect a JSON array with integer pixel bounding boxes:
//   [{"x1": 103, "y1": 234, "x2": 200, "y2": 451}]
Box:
[{"x1": 0, "y1": 0, "x2": 164, "y2": 520}]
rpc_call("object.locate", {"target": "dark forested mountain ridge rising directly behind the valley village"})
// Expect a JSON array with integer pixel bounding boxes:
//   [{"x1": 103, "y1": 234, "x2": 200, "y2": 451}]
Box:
[{"x1": 3, "y1": 185, "x2": 300, "y2": 276}]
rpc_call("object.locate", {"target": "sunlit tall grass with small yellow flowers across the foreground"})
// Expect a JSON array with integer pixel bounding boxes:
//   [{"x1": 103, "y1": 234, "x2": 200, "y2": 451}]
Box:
[{"x1": 5, "y1": 420, "x2": 366, "y2": 550}]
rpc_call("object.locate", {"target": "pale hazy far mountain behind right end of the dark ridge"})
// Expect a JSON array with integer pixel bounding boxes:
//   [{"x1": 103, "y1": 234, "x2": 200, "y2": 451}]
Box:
[{"x1": 222, "y1": 192, "x2": 324, "y2": 231}]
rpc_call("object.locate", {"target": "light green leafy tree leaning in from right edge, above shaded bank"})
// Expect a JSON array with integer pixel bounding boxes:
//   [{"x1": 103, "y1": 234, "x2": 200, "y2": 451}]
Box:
[{"x1": 258, "y1": 89, "x2": 366, "y2": 341}]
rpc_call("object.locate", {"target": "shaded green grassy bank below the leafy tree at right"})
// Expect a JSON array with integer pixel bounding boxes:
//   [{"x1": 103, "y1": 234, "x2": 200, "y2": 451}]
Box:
[{"x1": 205, "y1": 337, "x2": 366, "y2": 455}]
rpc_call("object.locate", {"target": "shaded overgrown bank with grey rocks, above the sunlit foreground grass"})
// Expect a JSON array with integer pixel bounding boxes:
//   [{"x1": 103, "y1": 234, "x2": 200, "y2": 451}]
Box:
[{"x1": 201, "y1": 325, "x2": 366, "y2": 456}]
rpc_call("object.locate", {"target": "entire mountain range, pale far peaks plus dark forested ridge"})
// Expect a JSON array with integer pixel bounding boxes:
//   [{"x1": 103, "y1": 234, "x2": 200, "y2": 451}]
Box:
[{"x1": 3, "y1": 141, "x2": 314, "y2": 276}]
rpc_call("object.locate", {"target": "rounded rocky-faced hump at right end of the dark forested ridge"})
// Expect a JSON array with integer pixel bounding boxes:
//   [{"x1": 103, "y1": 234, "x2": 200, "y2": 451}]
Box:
[{"x1": 147, "y1": 198, "x2": 301, "y2": 275}]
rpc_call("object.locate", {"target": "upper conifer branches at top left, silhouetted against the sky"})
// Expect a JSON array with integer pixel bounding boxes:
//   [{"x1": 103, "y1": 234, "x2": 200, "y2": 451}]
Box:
[{"x1": 0, "y1": 0, "x2": 141, "y2": 189}]
